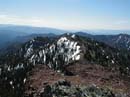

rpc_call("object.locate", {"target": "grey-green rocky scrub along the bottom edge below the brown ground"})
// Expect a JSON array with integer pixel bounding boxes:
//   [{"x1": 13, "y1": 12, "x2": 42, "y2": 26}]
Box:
[{"x1": 40, "y1": 80, "x2": 128, "y2": 97}]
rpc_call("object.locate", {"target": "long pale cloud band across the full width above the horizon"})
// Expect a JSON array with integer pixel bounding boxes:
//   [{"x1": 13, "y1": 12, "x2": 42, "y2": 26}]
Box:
[{"x1": 0, "y1": 14, "x2": 130, "y2": 30}]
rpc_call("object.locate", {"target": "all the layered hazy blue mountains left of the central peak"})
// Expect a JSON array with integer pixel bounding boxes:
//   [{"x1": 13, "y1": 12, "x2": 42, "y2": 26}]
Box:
[{"x1": 0, "y1": 24, "x2": 67, "y2": 49}]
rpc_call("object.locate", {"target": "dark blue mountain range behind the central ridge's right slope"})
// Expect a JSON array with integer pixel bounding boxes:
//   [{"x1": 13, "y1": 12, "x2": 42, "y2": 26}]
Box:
[{"x1": 76, "y1": 32, "x2": 130, "y2": 50}]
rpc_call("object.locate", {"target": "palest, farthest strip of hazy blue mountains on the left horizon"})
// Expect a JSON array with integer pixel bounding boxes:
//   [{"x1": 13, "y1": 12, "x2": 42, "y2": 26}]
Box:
[{"x1": 0, "y1": 24, "x2": 67, "y2": 34}]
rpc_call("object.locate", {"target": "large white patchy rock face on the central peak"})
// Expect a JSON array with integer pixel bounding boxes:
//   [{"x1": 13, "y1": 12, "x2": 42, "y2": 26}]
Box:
[{"x1": 26, "y1": 35, "x2": 81, "y2": 68}]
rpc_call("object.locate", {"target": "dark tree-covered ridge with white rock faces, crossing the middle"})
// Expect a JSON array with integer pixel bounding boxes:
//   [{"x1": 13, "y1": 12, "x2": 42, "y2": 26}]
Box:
[{"x1": 0, "y1": 33, "x2": 130, "y2": 97}]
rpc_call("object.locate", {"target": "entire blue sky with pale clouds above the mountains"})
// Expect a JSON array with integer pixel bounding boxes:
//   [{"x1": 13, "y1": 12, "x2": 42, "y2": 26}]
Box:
[{"x1": 0, "y1": 0, "x2": 130, "y2": 30}]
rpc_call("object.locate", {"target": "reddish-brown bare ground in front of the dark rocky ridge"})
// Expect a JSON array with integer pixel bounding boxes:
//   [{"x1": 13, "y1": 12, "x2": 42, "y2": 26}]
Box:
[{"x1": 25, "y1": 64, "x2": 130, "y2": 95}]
